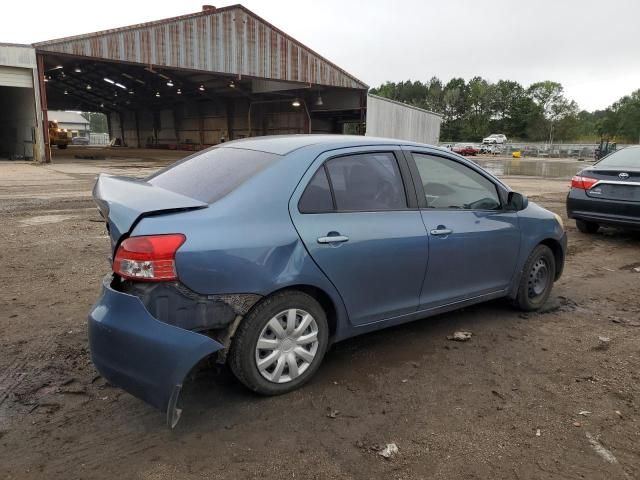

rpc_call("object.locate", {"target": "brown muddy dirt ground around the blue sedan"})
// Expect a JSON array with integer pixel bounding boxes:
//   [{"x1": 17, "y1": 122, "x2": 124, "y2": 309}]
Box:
[{"x1": 0, "y1": 149, "x2": 640, "y2": 480}]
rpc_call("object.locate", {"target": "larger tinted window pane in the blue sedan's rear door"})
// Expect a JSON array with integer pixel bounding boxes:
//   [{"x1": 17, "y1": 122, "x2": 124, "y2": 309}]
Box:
[{"x1": 325, "y1": 152, "x2": 407, "y2": 211}]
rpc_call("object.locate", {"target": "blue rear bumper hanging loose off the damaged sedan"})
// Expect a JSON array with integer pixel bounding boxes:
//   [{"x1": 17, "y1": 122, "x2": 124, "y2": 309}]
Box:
[{"x1": 89, "y1": 275, "x2": 223, "y2": 427}]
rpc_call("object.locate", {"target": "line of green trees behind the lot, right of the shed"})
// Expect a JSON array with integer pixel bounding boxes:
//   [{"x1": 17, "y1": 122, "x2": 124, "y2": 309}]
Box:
[{"x1": 371, "y1": 77, "x2": 640, "y2": 143}]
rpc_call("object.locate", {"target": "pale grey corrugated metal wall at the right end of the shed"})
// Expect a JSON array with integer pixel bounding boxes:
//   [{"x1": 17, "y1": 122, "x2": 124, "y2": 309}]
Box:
[{"x1": 366, "y1": 95, "x2": 442, "y2": 145}]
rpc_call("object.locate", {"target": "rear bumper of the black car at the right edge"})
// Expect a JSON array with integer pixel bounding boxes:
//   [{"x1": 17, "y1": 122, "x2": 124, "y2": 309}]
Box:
[{"x1": 567, "y1": 189, "x2": 640, "y2": 229}]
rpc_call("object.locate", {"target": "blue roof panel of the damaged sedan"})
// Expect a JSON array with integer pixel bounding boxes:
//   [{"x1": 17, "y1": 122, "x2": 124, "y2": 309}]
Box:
[{"x1": 219, "y1": 135, "x2": 433, "y2": 155}]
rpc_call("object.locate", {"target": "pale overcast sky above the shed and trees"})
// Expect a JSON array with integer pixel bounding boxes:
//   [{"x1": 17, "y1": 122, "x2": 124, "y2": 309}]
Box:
[{"x1": 0, "y1": 0, "x2": 640, "y2": 110}]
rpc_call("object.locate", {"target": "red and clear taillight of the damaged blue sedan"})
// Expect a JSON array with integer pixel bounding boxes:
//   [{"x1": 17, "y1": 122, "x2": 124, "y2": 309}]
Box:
[{"x1": 113, "y1": 233, "x2": 187, "y2": 282}]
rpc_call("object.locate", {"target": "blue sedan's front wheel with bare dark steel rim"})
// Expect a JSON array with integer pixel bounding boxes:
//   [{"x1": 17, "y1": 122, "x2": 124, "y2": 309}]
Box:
[{"x1": 515, "y1": 245, "x2": 556, "y2": 312}]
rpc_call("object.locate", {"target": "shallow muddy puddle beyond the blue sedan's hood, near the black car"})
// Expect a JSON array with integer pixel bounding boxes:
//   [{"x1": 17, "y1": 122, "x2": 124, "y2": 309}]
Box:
[{"x1": 474, "y1": 158, "x2": 592, "y2": 180}]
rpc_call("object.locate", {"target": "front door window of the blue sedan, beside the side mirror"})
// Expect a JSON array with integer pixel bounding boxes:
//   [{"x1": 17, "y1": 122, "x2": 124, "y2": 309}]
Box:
[{"x1": 413, "y1": 153, "x2": 500, "y2": 210}]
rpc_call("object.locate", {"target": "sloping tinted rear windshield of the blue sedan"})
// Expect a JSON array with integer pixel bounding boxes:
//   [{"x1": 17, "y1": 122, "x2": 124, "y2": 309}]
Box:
[{"x1": 151, "y1": 147, "x2": 279, "y2": 203}]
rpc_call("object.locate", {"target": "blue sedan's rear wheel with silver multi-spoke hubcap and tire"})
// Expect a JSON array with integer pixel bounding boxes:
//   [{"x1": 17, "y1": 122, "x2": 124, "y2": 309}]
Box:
[{"x1": 229, "y1": 291, "x2": 329, "y2": 395}]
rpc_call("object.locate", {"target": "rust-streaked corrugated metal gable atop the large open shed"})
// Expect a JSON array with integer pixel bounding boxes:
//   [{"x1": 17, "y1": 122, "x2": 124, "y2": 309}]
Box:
[{"x1": 33, "y1": 5, "x2": 368, "y2": 89}]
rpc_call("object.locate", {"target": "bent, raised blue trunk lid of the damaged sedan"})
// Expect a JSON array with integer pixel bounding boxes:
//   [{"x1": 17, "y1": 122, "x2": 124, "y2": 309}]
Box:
[{"x1": 93, "y1": 174, "x2": 208, "y2": 251}]
